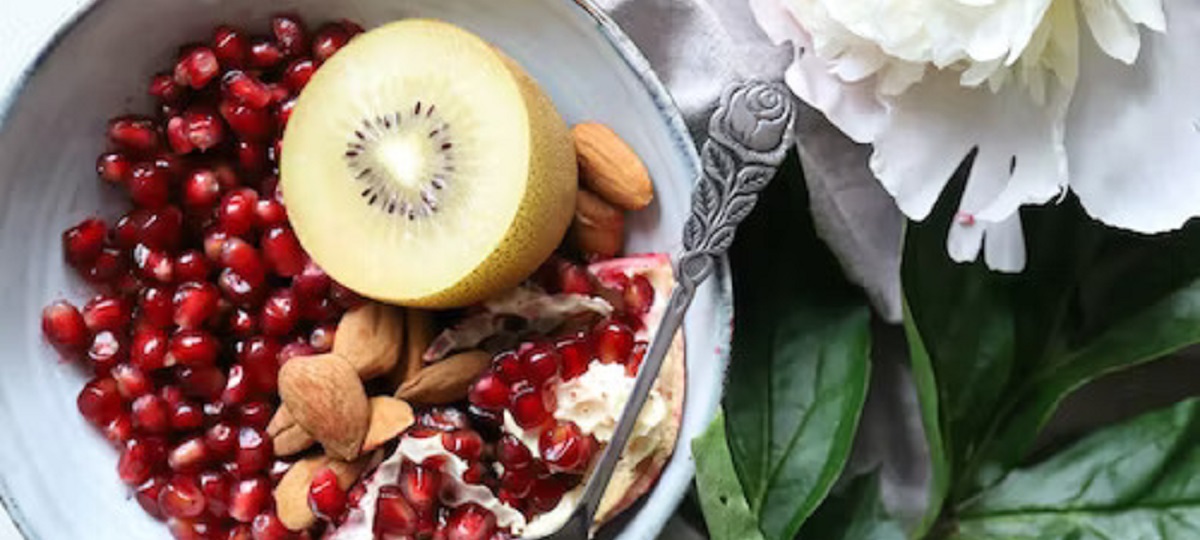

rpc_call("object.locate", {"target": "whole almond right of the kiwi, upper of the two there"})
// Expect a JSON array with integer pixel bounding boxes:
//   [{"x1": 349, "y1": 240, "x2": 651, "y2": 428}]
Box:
[{"x1": 571, "y1": 122, "x2": 654, "y2": 210}]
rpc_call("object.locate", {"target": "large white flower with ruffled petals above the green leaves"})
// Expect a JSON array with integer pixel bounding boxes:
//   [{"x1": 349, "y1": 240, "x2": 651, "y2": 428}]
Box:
[{"x1": 750, "y1": 0, "x2": 1185, "y2": 271}]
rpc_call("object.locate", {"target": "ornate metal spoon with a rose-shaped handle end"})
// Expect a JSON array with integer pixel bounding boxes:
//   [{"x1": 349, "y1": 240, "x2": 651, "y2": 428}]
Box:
[{"x1": 528, "y1": 80, "x2": 796, "y2": 540}]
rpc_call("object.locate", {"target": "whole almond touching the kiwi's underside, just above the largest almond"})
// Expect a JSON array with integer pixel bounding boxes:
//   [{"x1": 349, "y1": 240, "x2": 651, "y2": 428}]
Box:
[{"x1": 334, "y1": 302, "x2": 404, "y2": 380}]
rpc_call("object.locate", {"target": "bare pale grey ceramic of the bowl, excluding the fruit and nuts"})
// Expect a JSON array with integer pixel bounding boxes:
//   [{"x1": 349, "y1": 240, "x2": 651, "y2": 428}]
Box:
[{"x1": 0, "y1": 0, "x2": 732, "y2": 540}]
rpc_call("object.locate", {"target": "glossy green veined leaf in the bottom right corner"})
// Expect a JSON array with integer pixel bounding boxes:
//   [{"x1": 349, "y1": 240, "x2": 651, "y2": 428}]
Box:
[{"x1": 952, "y1": 400, "x2": 1200, "y2": 540}]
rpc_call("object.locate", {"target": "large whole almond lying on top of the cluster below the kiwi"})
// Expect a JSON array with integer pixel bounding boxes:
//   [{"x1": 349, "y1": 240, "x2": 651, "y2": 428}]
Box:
[{"x1": 280, "y1": 353, "x2": 371, "y2": 461}]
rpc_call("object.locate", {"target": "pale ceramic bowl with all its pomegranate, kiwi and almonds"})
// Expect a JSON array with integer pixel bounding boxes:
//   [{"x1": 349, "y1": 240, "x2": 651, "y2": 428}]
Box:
[{"x1": 0, "y1": 0, "x2": 731, "y2": 539}]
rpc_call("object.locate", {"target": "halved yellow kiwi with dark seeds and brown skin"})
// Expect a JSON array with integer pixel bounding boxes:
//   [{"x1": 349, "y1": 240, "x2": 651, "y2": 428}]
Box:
[{"x1": 280, "y1": 19, "x2": 577, "y2": 308}]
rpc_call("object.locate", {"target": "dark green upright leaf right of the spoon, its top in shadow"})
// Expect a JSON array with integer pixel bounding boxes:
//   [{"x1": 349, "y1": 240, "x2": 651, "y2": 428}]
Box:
[{"x1": 725, "y1": 160, "x2": 870, "y2": 540}]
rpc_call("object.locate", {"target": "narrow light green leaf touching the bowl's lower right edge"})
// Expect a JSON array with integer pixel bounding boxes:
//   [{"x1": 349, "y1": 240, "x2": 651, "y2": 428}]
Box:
[{"x1": 691, "y1": 414, "x2": 762, "y2": 540}]
